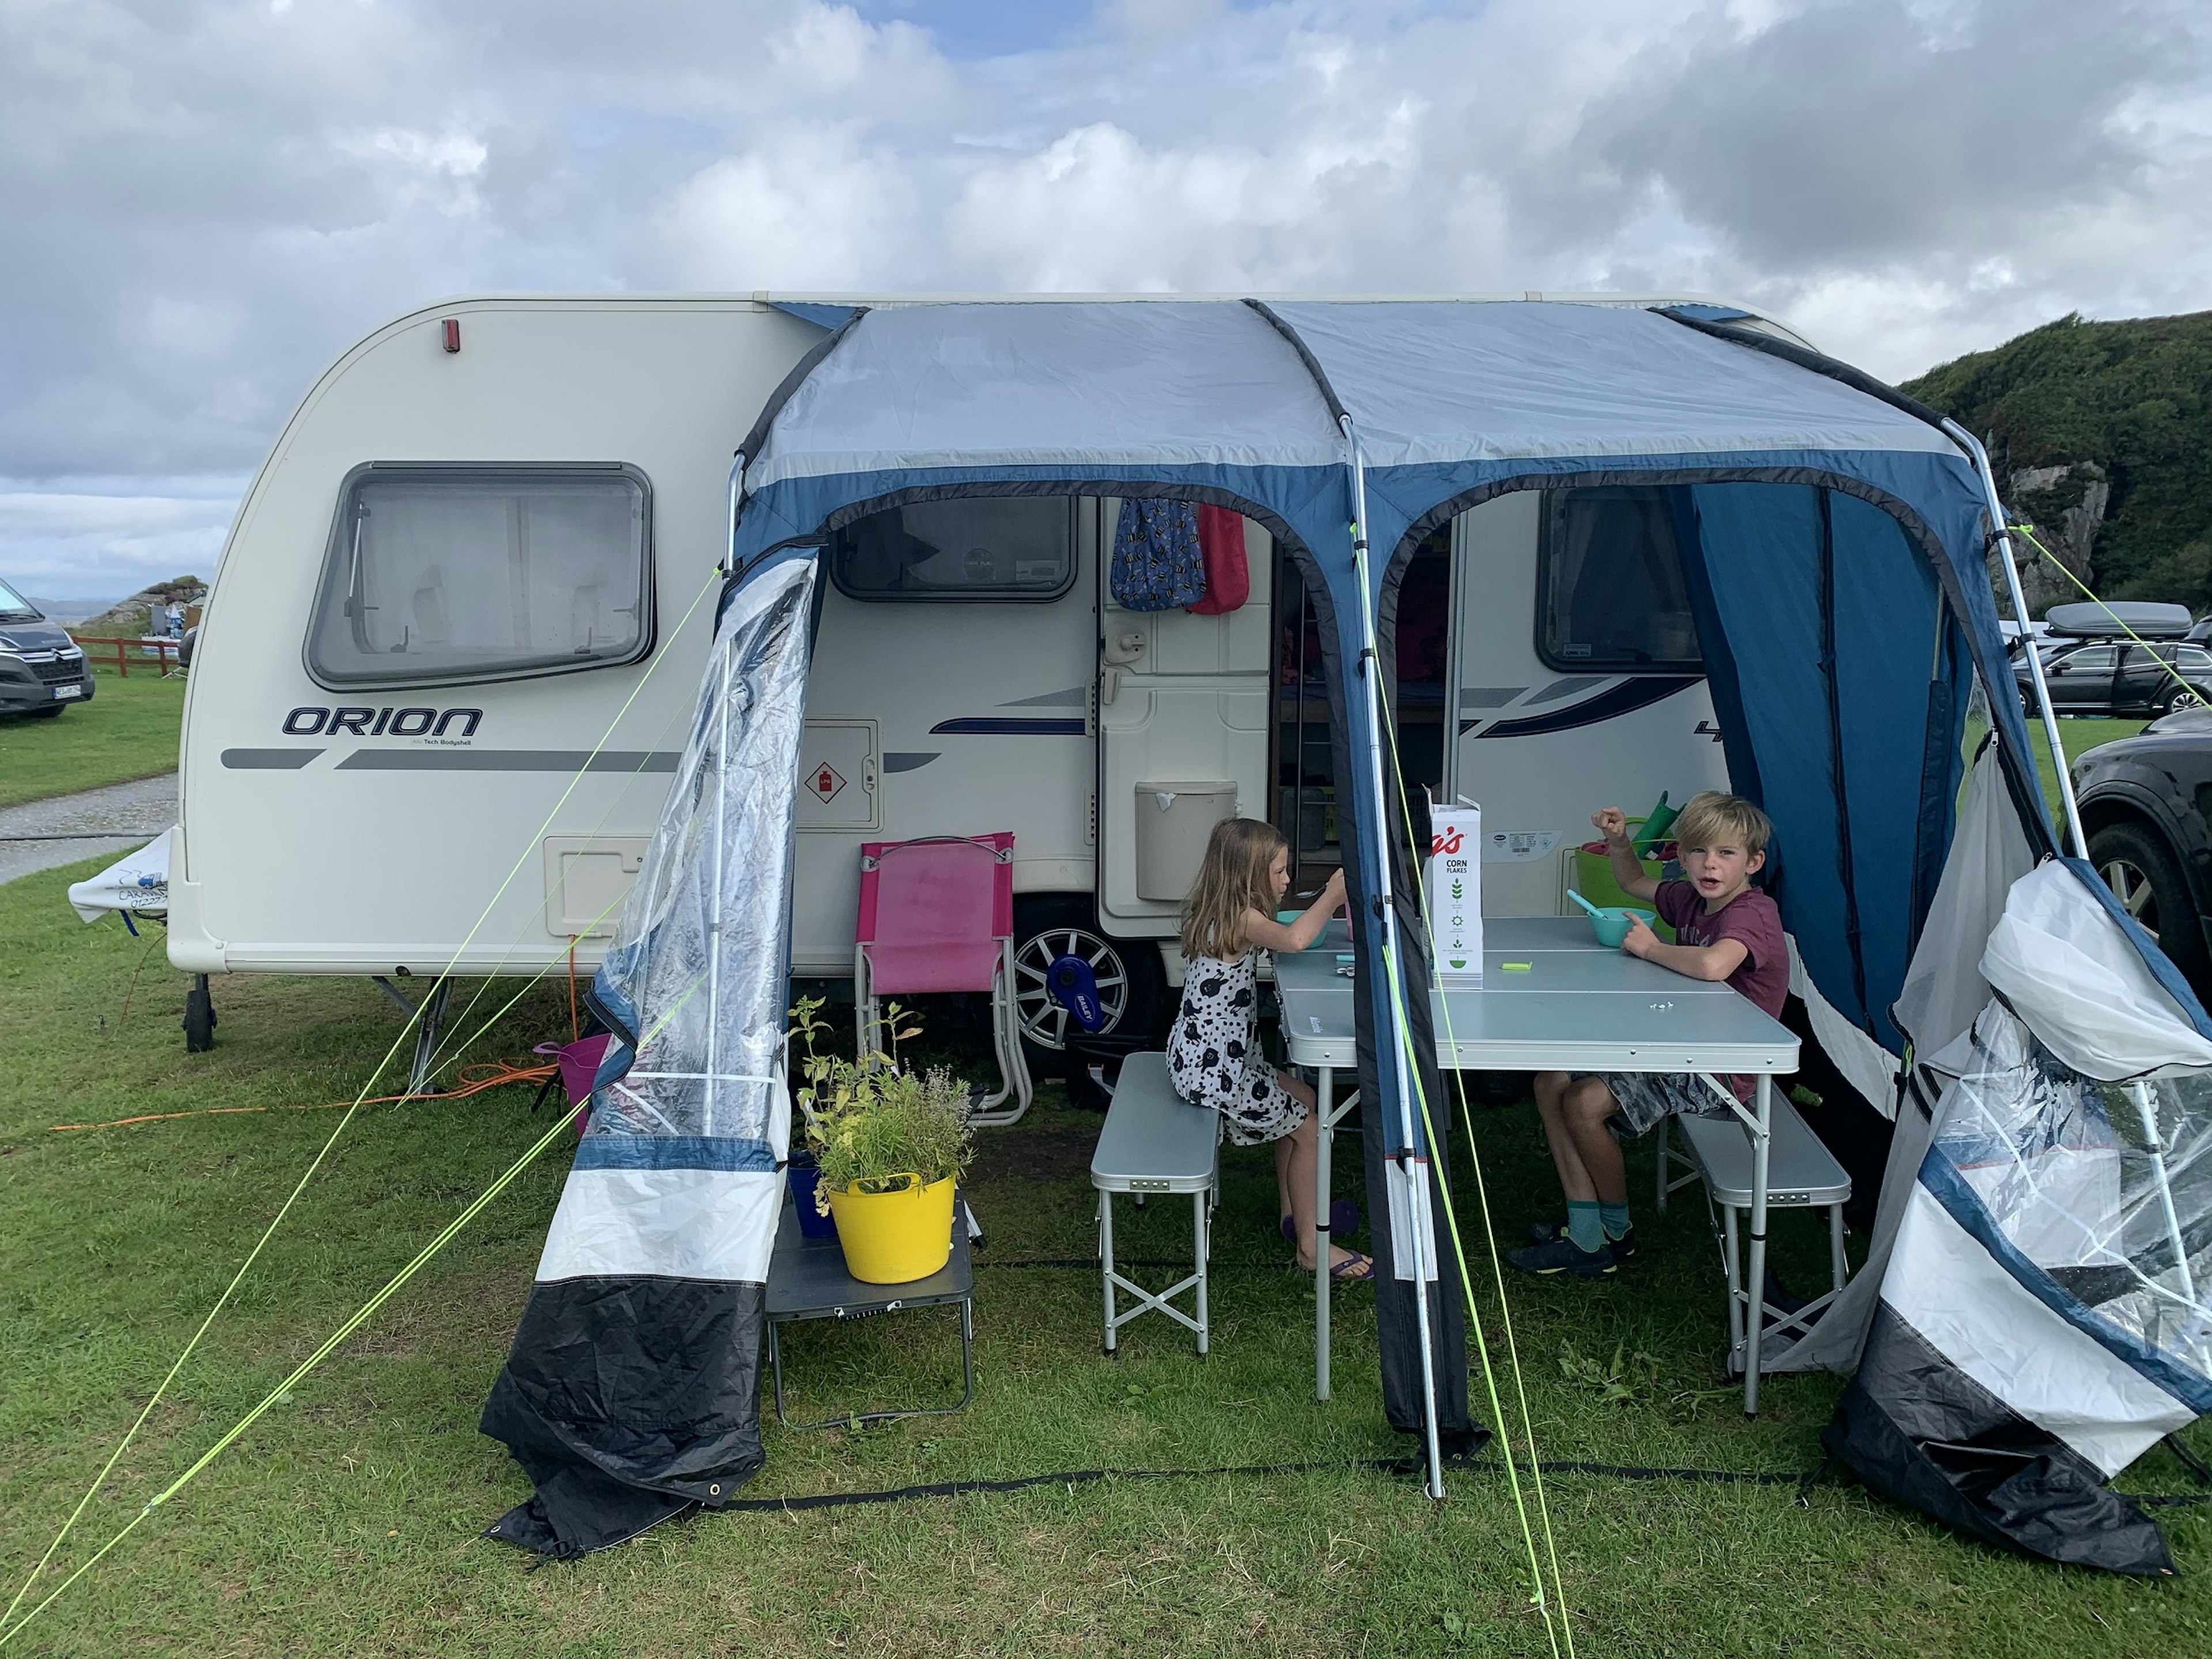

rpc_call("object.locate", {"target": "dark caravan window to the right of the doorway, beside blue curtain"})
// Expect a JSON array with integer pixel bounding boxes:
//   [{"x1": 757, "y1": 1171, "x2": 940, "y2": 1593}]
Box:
[{"x1": 1535, "y1": 484, "x2": 1706, "y2": 675}]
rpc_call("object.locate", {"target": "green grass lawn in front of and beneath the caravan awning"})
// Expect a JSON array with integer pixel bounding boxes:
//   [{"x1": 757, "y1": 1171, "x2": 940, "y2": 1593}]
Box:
[{"x1": 0, "y1": 861, "x2": 2212, "y2": 1659}]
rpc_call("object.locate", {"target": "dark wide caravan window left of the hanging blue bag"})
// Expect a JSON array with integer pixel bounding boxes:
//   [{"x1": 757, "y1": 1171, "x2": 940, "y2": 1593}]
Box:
[{"x1": 830, "y1": 495, "x2": 1075, "y2": 601}]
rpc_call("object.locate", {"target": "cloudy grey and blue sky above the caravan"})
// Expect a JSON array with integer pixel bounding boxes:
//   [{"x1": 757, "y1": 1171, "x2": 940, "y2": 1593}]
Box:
[{"x1": 0, "y1": 0, "x2": 2212, "y2": 597}]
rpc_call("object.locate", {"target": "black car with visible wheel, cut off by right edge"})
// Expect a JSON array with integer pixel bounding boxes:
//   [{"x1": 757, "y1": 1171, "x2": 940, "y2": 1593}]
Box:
[{"x1": 2073, "y1": 708, "x2": 2212, "y2": 995}]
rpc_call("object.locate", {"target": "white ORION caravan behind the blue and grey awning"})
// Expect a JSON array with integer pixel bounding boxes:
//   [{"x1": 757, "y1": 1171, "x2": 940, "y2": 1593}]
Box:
[{"x1": 168, "y1": 294, "x2": 1787, "y2": 1071}]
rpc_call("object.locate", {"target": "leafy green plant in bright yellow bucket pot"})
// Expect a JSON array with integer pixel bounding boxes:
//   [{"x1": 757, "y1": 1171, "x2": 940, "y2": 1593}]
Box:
[{"x1": 792, "y1": 998, "x2": 974, "y2": 1285}]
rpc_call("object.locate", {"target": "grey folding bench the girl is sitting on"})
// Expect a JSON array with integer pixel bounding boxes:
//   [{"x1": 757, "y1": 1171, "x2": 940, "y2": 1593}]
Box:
[{"x1": 1090, "y1": 1053, "x2": 1221, "y2": 1354}]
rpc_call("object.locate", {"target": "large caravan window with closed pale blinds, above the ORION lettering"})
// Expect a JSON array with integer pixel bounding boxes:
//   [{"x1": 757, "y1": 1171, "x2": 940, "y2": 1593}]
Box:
[{"x1": 308, "y1": 463, "x2": 653, "y2": 688}]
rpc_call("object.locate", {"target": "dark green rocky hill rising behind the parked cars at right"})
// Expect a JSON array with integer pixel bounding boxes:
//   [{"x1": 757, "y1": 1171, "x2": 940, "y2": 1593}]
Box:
[{"x1": 1900, "y1": 312, "x2": 2212, "y2": 613}]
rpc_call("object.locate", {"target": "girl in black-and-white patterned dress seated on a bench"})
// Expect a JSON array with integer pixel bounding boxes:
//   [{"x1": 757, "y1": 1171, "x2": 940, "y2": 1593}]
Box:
[{"x1": 1168, "y1": 819, "x2": 1374, "y2": 1279}]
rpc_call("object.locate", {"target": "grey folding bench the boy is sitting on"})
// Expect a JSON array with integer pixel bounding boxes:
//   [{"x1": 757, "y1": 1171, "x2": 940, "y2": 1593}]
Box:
[{"x1": 1659, "y1": 1080, "x2": 1851, "y2": 1372}]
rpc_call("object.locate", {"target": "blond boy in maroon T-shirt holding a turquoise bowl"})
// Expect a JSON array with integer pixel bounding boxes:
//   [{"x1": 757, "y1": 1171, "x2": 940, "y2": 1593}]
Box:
[{"x1": 1506, "y1": 790, "x2": 1790, "y2": 1279}]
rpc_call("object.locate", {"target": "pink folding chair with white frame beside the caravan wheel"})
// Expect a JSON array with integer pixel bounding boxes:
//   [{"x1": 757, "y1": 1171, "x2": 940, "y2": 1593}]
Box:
[{"x1": 851, "y1": 830, "x2": 1031, "y2": 1126}]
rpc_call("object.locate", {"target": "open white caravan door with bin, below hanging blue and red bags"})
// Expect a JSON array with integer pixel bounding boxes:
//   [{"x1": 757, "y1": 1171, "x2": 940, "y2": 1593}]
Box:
[{"x1": 1095, "y1": 511, "x2": 1274, "y2": 938}]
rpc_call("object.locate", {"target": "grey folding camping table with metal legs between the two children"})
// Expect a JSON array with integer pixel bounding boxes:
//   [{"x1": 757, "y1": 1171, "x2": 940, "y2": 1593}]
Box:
[{"x1": 1274, "y1": 916, "x2": 1798, "y2": 1414}]
